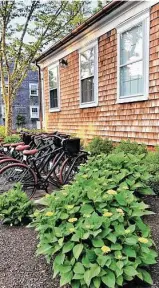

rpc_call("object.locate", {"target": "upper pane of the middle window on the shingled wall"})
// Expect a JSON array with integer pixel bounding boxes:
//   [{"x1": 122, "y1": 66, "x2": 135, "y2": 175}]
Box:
[{"x1": 80, "y1": 48, "x2": 94, "y2": 79}]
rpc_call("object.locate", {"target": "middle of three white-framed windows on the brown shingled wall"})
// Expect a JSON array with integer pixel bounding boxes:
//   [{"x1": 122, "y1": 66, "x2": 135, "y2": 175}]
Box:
[{"x1": 79, "y1": 41, "x2": 98, "y2": 108}]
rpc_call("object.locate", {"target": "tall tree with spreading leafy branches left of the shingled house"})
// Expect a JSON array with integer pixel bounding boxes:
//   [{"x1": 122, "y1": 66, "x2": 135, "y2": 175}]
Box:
[{"x1": 0, "y1": 0, "x2": 89, "y2": 135}]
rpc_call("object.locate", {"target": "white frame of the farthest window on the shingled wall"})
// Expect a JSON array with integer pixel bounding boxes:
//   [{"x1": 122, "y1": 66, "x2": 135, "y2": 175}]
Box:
[{"x1": 48, "y1": 62, "x2": 61, "y2": 112}]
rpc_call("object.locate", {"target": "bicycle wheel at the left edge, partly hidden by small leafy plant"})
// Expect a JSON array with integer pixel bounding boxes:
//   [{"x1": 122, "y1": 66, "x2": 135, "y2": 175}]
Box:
[{"x1": 0, "y1": 163, "x2": 37, "y2": 198}]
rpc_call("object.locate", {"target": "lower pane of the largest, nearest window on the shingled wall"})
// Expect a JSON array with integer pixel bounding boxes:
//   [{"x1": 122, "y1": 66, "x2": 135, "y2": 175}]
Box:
[{"x1": 120, "y1": 61, "x2": 144, "y2": 96}]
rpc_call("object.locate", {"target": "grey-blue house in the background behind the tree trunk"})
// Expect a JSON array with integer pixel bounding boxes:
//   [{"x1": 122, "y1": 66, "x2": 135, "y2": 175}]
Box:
[{"x1": 0, "y1": 70, "x2": 39, "y2": 129}]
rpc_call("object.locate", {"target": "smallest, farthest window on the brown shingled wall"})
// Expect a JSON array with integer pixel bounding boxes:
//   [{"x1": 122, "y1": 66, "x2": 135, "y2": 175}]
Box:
[{"x1": 49, "y1": 64, "x2": 60, "y2": 111}]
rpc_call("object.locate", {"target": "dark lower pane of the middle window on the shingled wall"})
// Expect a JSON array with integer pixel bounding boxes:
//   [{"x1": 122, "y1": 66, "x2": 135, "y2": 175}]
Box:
[{"x1": 81, "y1": 77, "x2": 94, "y2": 103}]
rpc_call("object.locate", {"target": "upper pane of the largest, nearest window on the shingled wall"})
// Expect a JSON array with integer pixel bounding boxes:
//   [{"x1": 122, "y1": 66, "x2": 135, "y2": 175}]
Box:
[{"x1": 120, "y1": 23, "x2": 143, "y2": 65}]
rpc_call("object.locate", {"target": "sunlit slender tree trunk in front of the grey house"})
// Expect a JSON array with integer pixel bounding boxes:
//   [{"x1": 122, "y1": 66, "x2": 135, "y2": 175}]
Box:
[{"x1": 5, "y1": 99, "x2": 13, "y2": 136}]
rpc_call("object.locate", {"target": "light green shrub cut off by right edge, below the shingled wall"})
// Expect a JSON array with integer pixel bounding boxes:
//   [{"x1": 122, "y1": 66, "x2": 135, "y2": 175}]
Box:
[{"x1": 145, "y1": 148, "x2": 159, "y2": 195}]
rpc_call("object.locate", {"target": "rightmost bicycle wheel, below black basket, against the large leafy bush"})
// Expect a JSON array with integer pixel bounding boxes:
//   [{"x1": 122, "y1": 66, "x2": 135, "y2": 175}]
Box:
[{"x1": 59, "y1": 154, "x2": 87, "y2": 185}]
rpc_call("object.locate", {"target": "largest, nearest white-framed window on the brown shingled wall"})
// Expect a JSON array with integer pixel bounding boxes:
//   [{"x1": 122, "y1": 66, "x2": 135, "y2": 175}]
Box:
[{"x1": 118, "y1": 15, "x2": 149, "y2": 103}]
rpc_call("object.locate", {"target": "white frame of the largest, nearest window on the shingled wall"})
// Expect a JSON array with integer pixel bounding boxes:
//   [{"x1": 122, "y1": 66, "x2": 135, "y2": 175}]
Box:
[{"x1": 117, "y1": 10, "x2": 150, "y2": 103}]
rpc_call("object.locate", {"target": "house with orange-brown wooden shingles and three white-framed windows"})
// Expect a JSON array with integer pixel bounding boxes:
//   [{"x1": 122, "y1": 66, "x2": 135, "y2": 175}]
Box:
[{"x1": 36, "y1": 0, "x2": 159, "y2": 145}]
